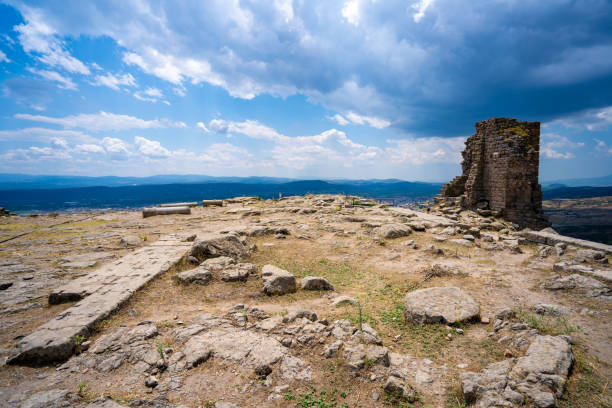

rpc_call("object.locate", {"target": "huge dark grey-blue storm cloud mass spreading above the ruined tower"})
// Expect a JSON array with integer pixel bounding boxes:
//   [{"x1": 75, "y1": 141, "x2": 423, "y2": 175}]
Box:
[{"x1": 4, "y1": 0, "x2": 612, "y2": 136}]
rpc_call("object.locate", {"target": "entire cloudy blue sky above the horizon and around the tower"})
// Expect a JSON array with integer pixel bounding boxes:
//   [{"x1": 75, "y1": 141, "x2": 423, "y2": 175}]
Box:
[{"x1": 0, "y1": 0, "x2": 612, "y2": 181}]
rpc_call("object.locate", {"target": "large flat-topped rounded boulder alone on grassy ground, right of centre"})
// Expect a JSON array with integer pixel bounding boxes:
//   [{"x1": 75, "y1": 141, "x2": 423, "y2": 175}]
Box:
[{"x1": 404, "y1": 287, "x2": 480, "y2": 324}]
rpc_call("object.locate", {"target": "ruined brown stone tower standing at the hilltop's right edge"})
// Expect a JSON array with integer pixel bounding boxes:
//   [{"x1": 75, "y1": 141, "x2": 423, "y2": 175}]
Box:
[{"x1": 435, "y1": 118, "x2": 550, "y2": 229}]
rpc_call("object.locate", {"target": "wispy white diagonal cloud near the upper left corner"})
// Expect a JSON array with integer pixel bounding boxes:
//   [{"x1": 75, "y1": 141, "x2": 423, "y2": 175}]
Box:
[{"x1": 14, "y1": 7, "x2": 90, "y2": 75}]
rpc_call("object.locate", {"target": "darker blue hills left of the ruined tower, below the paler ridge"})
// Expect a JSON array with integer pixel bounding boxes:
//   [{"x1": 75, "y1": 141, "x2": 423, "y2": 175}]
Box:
[{"x1": 0, "y1": 180, "x2": 442, "y2": 213}]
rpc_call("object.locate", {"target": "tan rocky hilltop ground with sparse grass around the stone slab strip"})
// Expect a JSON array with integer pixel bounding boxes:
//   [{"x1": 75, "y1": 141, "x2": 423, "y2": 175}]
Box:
[{"x1": 0, "y1": 195, "x2": 612, "y2": 408}]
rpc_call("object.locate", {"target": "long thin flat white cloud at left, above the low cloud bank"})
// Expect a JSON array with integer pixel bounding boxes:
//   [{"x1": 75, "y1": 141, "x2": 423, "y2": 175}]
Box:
[{"x1": 15, "y1": 111, "x2": 186, "y2": 132}]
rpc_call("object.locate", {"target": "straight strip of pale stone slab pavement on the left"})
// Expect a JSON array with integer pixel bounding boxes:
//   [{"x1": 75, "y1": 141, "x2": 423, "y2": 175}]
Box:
[{"x1": 7, "y1": 235, "x2": 193, "y2": 366}]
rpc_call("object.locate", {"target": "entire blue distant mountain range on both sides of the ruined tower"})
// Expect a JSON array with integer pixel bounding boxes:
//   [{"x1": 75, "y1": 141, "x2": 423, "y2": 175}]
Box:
[{"x1": 0, "y1": 174, "x2": 612, "y2": 213}]
